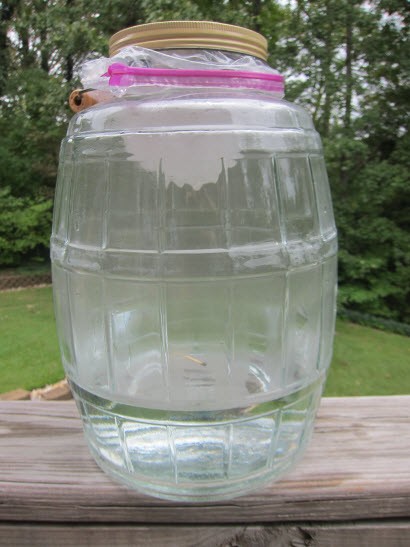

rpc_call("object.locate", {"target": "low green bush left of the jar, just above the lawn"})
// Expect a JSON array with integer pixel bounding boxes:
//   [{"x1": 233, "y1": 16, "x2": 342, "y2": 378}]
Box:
[{"x1": 0, "y1": 187, "x2": 52, "y2": 266}]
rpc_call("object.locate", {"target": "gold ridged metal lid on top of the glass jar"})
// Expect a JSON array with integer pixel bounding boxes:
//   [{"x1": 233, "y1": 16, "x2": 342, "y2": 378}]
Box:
[{"x1": 109, "y1": 21, "x2": 268, "y2": 61}]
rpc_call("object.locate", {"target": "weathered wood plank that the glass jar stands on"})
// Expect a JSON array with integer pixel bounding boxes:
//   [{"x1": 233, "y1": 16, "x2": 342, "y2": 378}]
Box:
[{"x1": 0, "y1": 396, "x2": 410, "y2": 524}]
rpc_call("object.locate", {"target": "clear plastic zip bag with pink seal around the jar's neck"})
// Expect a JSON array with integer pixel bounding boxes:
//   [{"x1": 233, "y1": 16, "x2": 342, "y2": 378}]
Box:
[{"x1": 81, "y1": 46, "x2": 284, "y2": 97}]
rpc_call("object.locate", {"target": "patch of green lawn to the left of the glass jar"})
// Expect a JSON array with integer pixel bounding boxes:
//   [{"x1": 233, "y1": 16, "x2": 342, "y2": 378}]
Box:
[{"x1": 0, "y1": 287, "x2": 64, "y2": 393}]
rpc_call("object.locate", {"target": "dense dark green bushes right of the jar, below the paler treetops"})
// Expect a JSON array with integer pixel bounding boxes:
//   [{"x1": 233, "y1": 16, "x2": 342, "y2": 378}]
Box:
[{"x1": 325, "y1": 132, "x2": 410, "y2": 322}]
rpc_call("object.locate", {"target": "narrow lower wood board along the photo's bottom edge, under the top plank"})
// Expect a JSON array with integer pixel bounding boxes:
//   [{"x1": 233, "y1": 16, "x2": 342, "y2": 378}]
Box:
[{"x1": 0, "y1": 522, "x2": 410, "y2": 547}]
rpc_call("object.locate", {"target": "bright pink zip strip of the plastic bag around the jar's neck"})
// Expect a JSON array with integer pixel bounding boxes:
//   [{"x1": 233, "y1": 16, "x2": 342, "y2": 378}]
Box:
[{"x1": 104, "y1": 63, "x2": 284, "y2": 93}]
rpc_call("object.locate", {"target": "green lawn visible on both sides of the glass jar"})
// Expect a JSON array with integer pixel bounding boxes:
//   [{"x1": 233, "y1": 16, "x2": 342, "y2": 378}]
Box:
[{"x1": 0, "y1": 287, "x2": 410, "y2": 396}]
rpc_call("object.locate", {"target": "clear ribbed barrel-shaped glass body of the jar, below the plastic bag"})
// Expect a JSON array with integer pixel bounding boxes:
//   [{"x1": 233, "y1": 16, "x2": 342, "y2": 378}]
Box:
[{"x1": 52, "y1": 80, "x2": 337, "y2": 500}]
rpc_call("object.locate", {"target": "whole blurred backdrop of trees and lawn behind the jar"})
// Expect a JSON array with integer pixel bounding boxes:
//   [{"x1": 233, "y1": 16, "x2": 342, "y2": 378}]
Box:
[{"x1": 0, "y1": 0, "x2": 410, "y2": 395}]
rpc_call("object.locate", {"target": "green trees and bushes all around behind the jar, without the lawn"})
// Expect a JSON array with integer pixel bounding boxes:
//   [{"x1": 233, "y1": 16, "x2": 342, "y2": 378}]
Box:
[{"x1": 0, "y1": 0, "x2": 410, "y2": 322}]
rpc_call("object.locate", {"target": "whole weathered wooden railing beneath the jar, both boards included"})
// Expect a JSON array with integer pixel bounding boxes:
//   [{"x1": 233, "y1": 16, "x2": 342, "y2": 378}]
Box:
[{"x1": 0, "y1": 396, "x2": 410, "y2": 547}]
